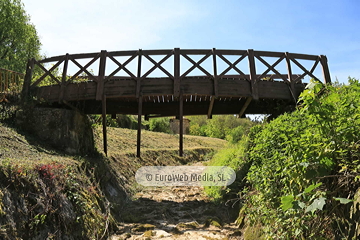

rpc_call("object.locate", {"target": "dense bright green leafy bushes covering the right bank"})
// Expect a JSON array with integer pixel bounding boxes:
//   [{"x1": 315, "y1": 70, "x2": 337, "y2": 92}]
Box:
[{"x1": 247, "y1": 79, "x2": 360, "y2": 239}]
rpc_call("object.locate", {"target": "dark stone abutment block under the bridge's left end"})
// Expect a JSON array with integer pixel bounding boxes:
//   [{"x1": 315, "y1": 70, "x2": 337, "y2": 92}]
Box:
[{"x1": 16, "y1": 107, "x2": 95, "y2": 155}]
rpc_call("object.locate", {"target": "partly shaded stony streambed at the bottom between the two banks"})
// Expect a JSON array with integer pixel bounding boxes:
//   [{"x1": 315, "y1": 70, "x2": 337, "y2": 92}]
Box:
[{"x1": 110, "y1": 187, "x2": 243, "y2": 240}]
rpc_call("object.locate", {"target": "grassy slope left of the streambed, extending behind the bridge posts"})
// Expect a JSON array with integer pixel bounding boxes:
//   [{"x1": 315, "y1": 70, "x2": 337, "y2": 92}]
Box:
[{"x1": 0, "y1": 123, "x2": 231, "y2": 239}]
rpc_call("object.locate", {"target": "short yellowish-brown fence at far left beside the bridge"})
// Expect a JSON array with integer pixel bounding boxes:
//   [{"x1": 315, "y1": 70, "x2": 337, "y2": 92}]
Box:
[{"x1": 0, "y1": 68, "x2": 25, "y2": 93}]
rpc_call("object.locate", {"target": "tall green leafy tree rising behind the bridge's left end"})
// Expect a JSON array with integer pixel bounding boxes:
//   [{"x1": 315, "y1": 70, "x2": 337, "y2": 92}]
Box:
[{"x1": 0, "y1": 0, "x2": 41, "y2": 73}]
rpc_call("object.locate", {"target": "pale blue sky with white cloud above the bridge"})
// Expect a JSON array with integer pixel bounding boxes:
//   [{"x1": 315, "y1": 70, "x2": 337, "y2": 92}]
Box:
[{"x1": 22, "y1": 0, "x2": 360, "y2": 82}]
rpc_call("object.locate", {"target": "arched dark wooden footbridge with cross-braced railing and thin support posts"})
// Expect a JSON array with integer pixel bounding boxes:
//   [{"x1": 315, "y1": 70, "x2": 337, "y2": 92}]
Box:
[{"x1": 22, "y1": 48, "x2": 331, "y2": 156}]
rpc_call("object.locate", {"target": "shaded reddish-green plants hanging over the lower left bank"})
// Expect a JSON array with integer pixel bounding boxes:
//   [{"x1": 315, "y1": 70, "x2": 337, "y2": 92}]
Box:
[{"x1": 0, "y1": 160, "x2": 112, "y2": 239}]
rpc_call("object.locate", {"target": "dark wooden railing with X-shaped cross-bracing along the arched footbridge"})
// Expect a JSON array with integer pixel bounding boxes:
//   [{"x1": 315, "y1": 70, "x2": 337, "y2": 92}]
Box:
[{"x1": 23, "y1": 48, "x2": 331, "y2": 100}]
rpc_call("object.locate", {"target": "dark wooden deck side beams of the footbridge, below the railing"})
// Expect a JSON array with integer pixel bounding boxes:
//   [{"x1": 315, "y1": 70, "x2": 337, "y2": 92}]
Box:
[{"x1": 35, "y1": 77, "x2": 305, "y2": 116}]
